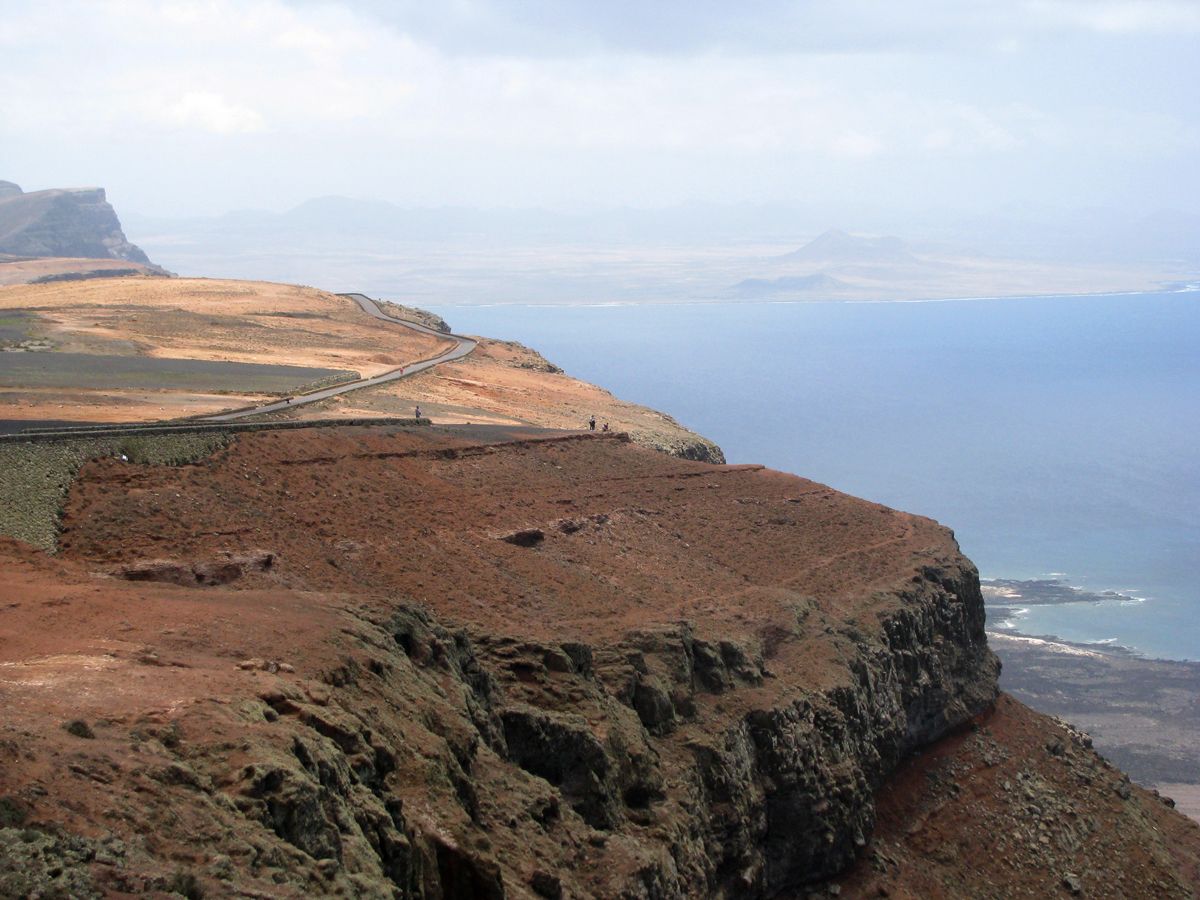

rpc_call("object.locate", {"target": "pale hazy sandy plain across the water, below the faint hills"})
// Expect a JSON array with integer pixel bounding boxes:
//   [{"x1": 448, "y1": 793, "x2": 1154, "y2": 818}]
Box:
[{"x1": 143, "y1": 234, "x2": 1196, "y2": 307}]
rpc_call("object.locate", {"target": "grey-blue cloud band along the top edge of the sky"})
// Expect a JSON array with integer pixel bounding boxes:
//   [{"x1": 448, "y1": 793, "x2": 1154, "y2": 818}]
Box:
[{"x1": 288, "y1": 0, "x2": 1200, "y2": 58}]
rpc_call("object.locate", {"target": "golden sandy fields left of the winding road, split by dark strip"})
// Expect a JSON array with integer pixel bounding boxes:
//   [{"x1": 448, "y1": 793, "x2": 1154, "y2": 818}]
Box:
[{"x1": 0, "y1": 278, "x2": 450, "y2": 421}]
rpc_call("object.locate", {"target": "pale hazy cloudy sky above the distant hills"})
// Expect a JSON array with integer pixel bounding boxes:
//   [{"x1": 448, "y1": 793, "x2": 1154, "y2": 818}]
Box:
[{"x1": 0, "y1": 0, "x2": 1200, "y2": 215}]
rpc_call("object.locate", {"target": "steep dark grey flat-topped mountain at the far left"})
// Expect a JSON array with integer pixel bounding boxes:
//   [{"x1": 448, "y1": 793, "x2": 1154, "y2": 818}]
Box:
[{"x1": 0, "y1": 181, "x2": 150, "y2": 265}]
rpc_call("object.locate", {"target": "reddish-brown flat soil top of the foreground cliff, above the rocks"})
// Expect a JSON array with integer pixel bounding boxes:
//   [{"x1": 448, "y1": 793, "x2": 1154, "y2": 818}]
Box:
[{"x1": 60, "y1": 428, "x2": 958, "y2": 657}]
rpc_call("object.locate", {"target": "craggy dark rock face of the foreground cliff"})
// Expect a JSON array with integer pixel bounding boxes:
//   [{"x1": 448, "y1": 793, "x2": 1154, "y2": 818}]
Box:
[{"x1": 58, "y1": 564, "x2": 997, "y2": 898}]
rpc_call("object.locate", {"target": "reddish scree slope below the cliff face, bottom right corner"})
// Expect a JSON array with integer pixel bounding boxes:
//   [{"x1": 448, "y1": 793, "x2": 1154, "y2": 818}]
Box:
[{"x1": 842, "y1": 696, "x2": 1200, "y2": 900}]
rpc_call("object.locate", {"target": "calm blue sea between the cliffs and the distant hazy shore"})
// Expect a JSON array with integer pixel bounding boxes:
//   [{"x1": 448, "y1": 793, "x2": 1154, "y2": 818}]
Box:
[{"x1": 436, "y1": 292, "x2": 1200, "y2": 659}]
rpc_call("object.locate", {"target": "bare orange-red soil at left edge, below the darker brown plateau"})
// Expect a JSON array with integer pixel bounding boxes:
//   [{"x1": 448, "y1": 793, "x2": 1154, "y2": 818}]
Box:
[{"x1": 0, "y1": 539, "x2": 352, "y2": 763}]
